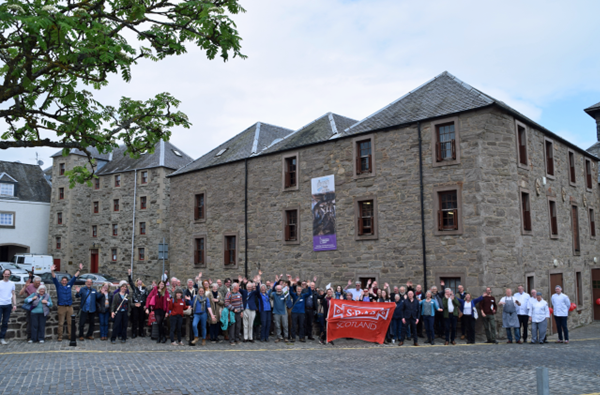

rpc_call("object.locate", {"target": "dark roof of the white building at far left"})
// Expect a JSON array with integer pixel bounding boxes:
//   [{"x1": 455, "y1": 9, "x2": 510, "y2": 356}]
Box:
[{"x1": 0, "y1": 161, "x2": 52, "y2": 203}]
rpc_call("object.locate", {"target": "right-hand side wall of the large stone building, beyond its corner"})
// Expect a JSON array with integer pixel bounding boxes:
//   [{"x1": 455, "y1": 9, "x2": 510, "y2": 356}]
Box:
[{"x1": 478, "y1": 106, "x2": 600, "y2": 326}]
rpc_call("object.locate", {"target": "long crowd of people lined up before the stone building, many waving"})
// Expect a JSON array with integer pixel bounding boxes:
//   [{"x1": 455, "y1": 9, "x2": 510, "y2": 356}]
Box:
[{"x1": 0, "y1": 264, "x2": 573, "y2": 346}]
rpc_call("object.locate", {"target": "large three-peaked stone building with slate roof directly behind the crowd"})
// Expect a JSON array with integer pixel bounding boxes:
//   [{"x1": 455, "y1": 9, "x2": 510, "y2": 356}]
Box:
[{"x1": 169, "y1": 72, "x2": 600, "y2": 334}]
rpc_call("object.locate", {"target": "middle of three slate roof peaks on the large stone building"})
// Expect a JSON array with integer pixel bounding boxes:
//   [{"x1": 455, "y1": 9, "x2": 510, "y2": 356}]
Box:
[{"x1": 260, "y1": 112, "x2": 357, "y2": 155}]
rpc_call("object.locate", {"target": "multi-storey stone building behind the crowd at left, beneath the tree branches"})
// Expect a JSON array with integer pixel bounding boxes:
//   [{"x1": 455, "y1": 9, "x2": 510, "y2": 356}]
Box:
[{"x1": 47, "y1": 141, "x2": 192, "y2": 280}]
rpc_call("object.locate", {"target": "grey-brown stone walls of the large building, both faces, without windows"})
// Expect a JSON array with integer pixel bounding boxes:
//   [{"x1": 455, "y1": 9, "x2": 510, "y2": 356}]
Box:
[{"x1": 170, "y1": 108, "x2": 600, "y2": 338}]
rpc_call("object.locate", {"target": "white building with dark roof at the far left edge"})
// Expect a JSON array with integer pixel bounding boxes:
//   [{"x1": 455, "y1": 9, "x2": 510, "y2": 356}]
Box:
[{"x1": 0, "y1": 161, "x2": 51, "y2": 262}]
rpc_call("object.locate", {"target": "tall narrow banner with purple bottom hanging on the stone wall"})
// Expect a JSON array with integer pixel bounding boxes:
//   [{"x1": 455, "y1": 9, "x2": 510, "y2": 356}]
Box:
[{"x1": 311, "y1": 175, "x2": 337, "y2": 251}]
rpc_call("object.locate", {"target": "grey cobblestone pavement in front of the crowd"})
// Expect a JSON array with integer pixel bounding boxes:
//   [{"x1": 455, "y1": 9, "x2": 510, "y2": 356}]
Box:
[{"x1": 0, "y1": 323, "x2": 600, "y2": 395}]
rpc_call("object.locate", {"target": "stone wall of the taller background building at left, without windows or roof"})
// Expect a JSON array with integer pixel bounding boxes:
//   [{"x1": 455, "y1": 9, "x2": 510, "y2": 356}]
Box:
[{"x1": 48, "y1": 155, "x2": 172, "y2": 282}]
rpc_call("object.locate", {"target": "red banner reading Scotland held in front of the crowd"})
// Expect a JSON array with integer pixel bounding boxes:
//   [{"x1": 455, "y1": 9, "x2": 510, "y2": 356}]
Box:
[{"x1": 327, "y1": 299, "x2": 396, "y2": 344}]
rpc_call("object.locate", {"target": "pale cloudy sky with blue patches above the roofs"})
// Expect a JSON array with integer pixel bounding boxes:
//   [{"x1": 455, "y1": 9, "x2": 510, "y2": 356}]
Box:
[{"x1": 0, "y1": 0, "x2": 600, "y2": 167}]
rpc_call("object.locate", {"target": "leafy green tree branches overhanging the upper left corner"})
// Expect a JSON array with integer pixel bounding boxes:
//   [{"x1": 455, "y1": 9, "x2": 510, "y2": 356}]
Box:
[{"x1": 0, "y1": 0, "x2": 245, "y2": 185}]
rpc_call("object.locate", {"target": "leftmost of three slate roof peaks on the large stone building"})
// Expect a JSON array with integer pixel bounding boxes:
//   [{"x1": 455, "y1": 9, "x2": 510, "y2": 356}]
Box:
[{"x1": 170, "y1": 122, "x2": 292, "y2": 176}]
